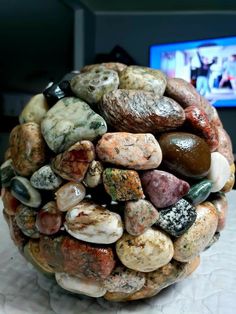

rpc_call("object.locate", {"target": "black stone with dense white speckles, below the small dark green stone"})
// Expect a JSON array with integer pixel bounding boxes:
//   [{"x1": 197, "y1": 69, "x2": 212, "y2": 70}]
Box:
[{"x1": 156, "y1": 199, "x2": 197, "y2": 237}]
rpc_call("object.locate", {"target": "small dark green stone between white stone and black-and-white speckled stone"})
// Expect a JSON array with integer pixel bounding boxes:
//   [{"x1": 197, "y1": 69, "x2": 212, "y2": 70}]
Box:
[{"x1": 184, "y1": 180, "x2": 212, "y2": 205}]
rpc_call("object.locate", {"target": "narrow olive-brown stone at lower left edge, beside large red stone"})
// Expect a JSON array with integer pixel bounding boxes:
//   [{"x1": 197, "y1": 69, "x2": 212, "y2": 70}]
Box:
[{"x1": 24, "y1": 239, "x2": 54, "y2": 277}]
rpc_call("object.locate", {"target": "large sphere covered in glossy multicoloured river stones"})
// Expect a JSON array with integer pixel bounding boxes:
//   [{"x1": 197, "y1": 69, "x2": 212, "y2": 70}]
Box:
[{"x1": 1, "y1": 63, "x2": 235, "y2": 301}]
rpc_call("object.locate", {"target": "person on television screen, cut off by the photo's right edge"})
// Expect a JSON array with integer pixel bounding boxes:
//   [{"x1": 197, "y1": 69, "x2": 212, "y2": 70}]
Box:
[{"x1": 220, "y1": 54, "x2": 236, "y2": 93}]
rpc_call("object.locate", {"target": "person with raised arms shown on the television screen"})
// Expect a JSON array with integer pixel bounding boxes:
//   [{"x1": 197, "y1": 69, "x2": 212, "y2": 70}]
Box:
[{"x1": 196, "y1": 51, "x2": 217, "y2": 96}]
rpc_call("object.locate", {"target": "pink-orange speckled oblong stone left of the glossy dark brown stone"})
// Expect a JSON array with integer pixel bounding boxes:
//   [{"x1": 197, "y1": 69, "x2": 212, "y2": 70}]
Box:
[{"x1": 96, "y1": 132, "x2": 162, "y2": 170}]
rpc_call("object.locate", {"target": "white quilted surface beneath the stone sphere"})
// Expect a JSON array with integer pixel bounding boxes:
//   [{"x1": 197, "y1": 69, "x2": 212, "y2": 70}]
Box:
[{"x1": 0, "y1": 191, "x2": 236, "y2": 314}]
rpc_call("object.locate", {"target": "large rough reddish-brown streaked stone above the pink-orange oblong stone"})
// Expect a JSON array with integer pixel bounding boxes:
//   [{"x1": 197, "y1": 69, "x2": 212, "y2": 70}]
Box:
[{"x1": 100, "y1": 89, "x2": 185, "y2": 134}]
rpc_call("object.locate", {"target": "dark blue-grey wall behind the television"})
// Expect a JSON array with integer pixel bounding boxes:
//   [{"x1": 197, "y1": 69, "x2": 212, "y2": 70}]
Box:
[{"x1": 95, "y1": 12, "x2": 236, "y2": 152}]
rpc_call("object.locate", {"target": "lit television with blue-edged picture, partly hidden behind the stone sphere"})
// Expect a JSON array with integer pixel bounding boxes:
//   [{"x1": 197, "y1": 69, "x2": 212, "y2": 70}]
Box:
[{"x1": 149, "y1": 36, "x2": 236, "y2": 107}]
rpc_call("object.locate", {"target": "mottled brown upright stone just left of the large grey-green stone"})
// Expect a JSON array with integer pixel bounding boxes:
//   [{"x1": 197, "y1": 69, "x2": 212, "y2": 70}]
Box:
[{"x1": 10, "y1": 122, "x2": 46, "y2": 176}]
